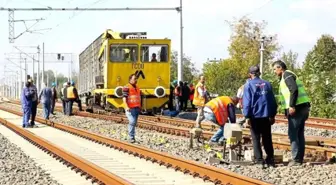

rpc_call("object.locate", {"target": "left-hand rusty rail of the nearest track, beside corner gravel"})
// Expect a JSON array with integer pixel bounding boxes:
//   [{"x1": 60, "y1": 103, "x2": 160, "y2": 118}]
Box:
[{"x1": 0, "y1": 118, "x2": 133, "y2": 185}]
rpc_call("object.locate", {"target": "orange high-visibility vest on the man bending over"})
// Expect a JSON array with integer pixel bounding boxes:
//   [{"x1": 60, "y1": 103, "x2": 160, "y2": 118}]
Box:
[{"x1": 205, "y1": 96, "x2": 233, "y2": 126}]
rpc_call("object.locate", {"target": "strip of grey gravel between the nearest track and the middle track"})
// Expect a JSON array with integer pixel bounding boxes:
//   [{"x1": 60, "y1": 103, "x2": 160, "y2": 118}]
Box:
[{"x1": 2, "y1": 104, "x2": 336, "y2": 185}]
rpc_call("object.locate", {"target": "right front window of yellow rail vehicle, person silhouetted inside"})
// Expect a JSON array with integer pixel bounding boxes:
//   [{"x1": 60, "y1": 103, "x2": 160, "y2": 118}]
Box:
[{"x1": 141, "y1": 44, "x2": 168, "y2": 62}]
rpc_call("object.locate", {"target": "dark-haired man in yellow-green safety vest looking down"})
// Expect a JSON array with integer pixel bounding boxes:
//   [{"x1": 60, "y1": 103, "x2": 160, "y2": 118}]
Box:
[{"x1": 273, "y1": 60, "x2": 310, "y2": 166}]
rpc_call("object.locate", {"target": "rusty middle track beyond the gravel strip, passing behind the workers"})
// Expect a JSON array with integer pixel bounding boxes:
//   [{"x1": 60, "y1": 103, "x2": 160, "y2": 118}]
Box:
[{"x1": 0, "y1": 101, "x2": 336, "y2": 158}]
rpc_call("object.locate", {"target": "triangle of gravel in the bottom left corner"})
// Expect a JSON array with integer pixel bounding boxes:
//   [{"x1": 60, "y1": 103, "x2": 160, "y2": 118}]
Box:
[{"x1": 0, "y1": 134, "x2": 59, "y2": 185}]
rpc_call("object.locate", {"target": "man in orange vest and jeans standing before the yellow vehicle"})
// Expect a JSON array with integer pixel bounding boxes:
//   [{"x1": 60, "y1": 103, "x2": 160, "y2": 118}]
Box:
[{"x1": 123, "y1": 74, "x2": 141, "y2": 143}]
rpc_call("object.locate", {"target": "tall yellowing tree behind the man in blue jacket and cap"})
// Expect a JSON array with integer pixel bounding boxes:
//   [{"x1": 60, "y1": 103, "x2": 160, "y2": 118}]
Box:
[{"x1": 203, "y1": 17, "x2": 279, "y2": 95}]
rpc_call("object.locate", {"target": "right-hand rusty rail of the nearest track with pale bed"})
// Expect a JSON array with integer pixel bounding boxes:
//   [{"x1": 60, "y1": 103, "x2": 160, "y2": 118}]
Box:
[{"x1": 0, "y1": 107, "x2": 269, "y2": 185}]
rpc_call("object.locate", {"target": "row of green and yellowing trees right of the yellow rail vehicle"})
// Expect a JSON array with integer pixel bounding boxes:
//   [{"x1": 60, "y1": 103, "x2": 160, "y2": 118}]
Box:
[{"x1": 171, "y1": 17, "x2": 336, "y2": 118}]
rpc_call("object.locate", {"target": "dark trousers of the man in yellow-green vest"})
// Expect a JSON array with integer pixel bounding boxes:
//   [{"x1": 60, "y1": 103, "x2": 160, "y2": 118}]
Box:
[{"x1": 288, "y1": 107, "x2": 309, "y2": 163}]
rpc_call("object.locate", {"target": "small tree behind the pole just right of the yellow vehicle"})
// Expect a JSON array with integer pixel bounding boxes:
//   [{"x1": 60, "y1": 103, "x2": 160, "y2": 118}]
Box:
[{"x1": 170, "y1": 51, "x2": 199, "y2": 83}]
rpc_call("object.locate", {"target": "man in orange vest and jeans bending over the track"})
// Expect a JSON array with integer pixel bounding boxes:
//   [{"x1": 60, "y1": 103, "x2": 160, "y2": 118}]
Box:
[{"x1": 204, "y1": 96, "x2": 239, "y2": 144}]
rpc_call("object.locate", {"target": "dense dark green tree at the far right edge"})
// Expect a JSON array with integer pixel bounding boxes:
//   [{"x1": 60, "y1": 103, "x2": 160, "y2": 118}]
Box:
[{"x1": 301, "y1": 35, "x2": 336, "y2": 118}]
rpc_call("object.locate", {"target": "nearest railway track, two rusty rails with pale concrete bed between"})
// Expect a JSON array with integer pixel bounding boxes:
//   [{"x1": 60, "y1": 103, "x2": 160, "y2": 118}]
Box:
[{"x1": 0, "y1": 110, "x2": 268, "y2": 185}]
